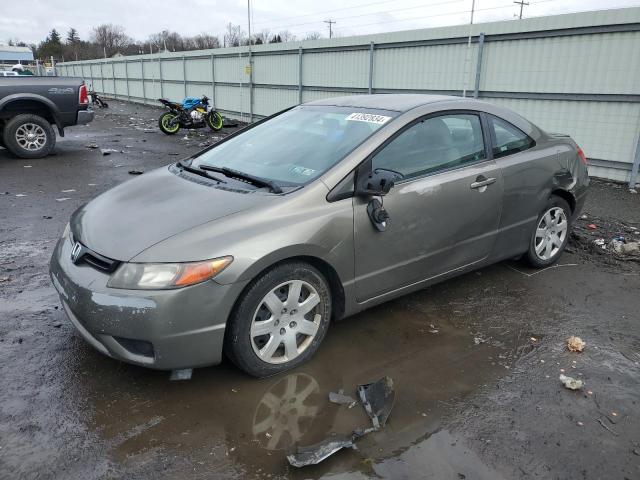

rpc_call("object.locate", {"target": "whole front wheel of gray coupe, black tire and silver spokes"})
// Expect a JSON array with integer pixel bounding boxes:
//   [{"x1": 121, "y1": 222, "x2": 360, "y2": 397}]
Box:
[{"x1": 224, "y1": 262, "x2": 331, "y2": 377}]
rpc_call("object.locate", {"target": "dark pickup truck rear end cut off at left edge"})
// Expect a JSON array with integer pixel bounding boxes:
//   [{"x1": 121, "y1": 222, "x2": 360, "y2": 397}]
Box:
[{"x1": 0, "y1": 75, "x2": 93, "y2": 158}]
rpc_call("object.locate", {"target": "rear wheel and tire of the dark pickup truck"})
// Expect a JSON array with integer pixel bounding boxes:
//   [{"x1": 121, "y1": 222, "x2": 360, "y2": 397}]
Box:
[{"x1": 2, "y1": 114, "x2": 56, "y2": 158}]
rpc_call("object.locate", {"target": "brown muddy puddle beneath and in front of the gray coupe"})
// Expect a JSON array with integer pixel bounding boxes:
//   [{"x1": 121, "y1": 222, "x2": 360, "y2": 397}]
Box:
[{"x1": 50, "y1": 297, "x2": 535, "y2": 478}]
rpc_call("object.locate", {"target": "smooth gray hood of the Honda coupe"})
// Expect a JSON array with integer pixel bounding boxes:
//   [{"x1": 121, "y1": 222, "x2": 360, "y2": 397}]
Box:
[{"x1": 71, "y1": 167, "x2": 273, "y2": 261}]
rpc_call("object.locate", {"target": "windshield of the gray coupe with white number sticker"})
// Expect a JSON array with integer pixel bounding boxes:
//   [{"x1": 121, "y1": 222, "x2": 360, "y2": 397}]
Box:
[{"x1": 191, "y1": 106, "x2": 397, "y2": 186}]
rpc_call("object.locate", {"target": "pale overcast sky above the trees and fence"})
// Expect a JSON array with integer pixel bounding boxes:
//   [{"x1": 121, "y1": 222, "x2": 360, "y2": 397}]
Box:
[{"x1": 0, "y1": 0, "x2": 640, "y2": 43}]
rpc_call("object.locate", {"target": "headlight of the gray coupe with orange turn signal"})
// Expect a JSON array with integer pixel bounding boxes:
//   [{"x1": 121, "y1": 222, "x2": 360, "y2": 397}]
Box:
[{"x1": 107, "y1": 257, "x2": 233, "y2": 290}]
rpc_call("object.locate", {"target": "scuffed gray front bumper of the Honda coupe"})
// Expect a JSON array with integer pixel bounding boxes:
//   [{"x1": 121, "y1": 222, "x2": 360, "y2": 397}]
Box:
[{"x1": 49, "y1": 234, "x2": 246, "y2": 370}]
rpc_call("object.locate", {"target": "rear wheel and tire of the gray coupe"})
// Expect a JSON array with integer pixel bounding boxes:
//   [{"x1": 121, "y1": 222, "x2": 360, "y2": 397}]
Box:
[{"x1": 524, "y1": 195, "x2": 571, "y2": 268}]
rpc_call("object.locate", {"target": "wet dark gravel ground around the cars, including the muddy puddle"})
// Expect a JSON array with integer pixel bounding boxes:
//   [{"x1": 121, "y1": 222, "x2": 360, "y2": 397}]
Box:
[{"x1": 0, "y1": 101, "x2": 640, "y2": 480}]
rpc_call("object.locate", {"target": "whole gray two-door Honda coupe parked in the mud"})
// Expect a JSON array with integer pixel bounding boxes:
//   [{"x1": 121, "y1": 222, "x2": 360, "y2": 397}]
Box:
[{"x1": 50, "y1": 95, "x2": 589, "y2": 377}]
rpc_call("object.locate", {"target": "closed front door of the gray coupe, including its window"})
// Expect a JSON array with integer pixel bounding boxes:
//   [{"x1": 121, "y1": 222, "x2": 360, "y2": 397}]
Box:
[{"x1": 354, "y1": 111, "x2": 502, "y2": 302}]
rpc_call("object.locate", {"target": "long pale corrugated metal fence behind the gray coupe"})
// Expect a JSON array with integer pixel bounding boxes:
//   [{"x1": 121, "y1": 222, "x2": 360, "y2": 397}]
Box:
[{"x1": 58, "y1": 8, "x2": 640, "y2": 188}]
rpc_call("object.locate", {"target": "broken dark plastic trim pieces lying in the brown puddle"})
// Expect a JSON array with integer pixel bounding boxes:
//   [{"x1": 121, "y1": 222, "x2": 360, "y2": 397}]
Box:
[{"x1": 287, "y1": 377, "x2": 395, "y2": 467}]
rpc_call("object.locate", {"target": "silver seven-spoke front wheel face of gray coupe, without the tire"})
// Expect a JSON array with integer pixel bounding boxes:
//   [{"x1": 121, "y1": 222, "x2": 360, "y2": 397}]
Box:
[{"x1": 250, "y1": 280, "x2": 322, "y2": 364}]
